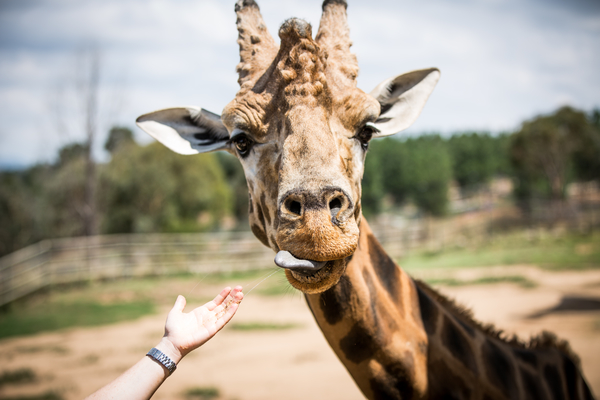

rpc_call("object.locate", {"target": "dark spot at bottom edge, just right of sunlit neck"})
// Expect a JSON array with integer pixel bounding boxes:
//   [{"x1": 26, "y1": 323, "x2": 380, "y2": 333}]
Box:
[{"x1": 427, "y1": 360, "x2": 471, "y2": 400}]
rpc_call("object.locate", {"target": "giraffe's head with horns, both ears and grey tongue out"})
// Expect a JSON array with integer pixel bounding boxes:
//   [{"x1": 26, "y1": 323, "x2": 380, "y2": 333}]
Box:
[{"x1": 137, "y1": 0, "x2": 439, "y2": 293}]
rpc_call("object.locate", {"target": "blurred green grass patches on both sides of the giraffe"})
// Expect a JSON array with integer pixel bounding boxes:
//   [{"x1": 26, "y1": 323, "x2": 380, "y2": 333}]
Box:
[{"x1": 0, "y1": 232, "x2": 600, "y2": 339}]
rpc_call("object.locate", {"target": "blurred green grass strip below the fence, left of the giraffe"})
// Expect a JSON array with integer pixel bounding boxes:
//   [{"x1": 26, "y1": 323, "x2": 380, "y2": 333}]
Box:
[{"x1": 0, "y1": 268, "x2": 293, "y2": 339}]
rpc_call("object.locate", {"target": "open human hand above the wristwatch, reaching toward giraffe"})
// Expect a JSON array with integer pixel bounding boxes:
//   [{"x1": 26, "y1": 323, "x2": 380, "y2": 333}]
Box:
[{"x1": 157, "y1": 286, "x2": 244, "y2": 363}]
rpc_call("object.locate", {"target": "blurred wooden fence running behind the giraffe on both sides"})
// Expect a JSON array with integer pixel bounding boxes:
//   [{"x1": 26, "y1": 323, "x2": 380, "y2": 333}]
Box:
[{"x1": 0, "y1": 195, "x2": 600, "y2": 305}]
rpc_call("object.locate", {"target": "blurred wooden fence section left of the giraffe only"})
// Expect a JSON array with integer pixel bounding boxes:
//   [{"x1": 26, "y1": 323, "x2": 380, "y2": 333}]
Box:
[{"x1": 0, "y1": 232, "x2": 274, "y2": 305}]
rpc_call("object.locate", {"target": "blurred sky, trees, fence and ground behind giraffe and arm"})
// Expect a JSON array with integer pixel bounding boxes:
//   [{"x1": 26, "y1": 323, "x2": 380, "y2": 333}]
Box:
[{"x1": 0, "y1": 0, "x2": 600, "y2": 399}]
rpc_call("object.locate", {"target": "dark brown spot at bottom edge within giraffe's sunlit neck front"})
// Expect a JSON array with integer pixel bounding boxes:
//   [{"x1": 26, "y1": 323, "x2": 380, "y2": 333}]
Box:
[{"x1": 369, "y1": 362, "x2": 414, "y2": 400}]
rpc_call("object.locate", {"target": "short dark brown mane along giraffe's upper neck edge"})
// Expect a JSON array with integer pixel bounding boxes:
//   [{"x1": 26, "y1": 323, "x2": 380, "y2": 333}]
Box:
[{"x1": 413, "y1": 279, "x2": 581, "y2": 368}]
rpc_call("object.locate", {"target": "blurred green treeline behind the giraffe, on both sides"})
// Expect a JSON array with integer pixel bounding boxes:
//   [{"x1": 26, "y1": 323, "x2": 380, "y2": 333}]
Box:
[{"x1": 0, "y1": 107, "x2": 600, "y2": 256}]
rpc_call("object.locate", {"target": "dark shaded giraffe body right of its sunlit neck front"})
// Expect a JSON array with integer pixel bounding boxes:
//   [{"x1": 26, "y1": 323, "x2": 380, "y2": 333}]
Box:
[{"x1": 417, "y1": 272, "x2": 592, "y2": 399}]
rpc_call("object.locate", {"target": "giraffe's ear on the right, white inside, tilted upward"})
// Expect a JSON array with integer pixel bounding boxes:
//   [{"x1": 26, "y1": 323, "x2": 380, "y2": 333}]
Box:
[{"x1": 370, "y1": 68, "x2": 440, "y2": 137}]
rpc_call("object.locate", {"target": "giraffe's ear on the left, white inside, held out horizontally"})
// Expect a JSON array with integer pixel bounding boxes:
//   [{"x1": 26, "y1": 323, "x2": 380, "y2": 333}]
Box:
[{"x1": 135, "y1": 107, "x2": 229, "y2": 154}]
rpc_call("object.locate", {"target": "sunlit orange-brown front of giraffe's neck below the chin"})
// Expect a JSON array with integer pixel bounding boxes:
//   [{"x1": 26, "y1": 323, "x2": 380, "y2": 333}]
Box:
[{"x1": 306, "y1": 218, "x2": 427, "y2": 399}]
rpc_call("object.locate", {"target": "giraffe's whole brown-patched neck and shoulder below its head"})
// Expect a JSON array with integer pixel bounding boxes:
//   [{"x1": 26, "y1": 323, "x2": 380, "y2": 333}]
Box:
[{"x1": 306, "y1": 218, "x2": 592, "y2": 399}]
